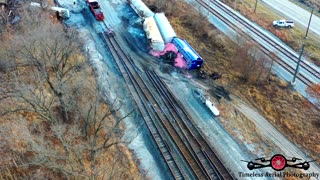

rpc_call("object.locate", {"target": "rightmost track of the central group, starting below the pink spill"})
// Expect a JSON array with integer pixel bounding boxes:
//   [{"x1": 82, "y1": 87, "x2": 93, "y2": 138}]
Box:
[{"x1": 147, "y1": 71, "x2": 234, "y2": 179}]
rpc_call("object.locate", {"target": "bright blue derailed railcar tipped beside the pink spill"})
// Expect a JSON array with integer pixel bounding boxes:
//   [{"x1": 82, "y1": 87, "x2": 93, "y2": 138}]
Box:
[{"x1": 172, "y1": 37, "x2": 203, "y2": 70}]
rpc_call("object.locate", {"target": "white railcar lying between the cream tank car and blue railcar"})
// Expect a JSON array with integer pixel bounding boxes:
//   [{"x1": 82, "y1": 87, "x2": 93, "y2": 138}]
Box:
[{"x1": 154, "y1": 13, "x2": 177, "y2": 43}]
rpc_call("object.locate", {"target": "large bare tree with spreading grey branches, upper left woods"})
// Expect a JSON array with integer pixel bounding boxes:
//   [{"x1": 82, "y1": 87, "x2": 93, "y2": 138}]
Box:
[{"x1": 0, "y1": 20, "x2": 85, "y2": 122}]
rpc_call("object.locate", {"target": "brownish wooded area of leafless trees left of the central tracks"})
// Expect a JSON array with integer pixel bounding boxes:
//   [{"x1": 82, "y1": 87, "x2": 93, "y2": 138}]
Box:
[{"x1": 0, "y1": 6, "x2": 139, "y2": 179}]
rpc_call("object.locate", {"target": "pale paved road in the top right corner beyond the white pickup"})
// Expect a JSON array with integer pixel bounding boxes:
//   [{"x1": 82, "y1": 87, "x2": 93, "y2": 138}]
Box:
[{"x1": 262, "y1": 0, "x2": 320, "y2": 36}]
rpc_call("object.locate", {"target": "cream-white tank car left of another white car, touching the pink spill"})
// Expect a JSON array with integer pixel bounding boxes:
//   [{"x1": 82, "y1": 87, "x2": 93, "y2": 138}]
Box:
[{"x1": 143, "y1": 17, "x2": 164, "y2": 51}]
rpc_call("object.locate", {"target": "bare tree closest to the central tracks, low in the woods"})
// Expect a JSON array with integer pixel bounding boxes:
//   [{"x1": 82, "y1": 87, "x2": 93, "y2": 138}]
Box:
[{"x1": 77, "y1": 92, "x2": 133, "y2": 179}]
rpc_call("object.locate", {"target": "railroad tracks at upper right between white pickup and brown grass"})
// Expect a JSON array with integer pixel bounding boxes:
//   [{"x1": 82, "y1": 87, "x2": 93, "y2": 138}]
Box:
[{"x1": 196, "y1": 0, "x2": 320, "y2": 85}]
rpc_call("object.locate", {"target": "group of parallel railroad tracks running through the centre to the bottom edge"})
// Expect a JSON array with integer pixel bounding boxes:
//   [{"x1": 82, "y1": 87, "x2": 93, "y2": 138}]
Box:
[{"x1": 100, "y1": 23, "x2": 232, "y2": 179}]
